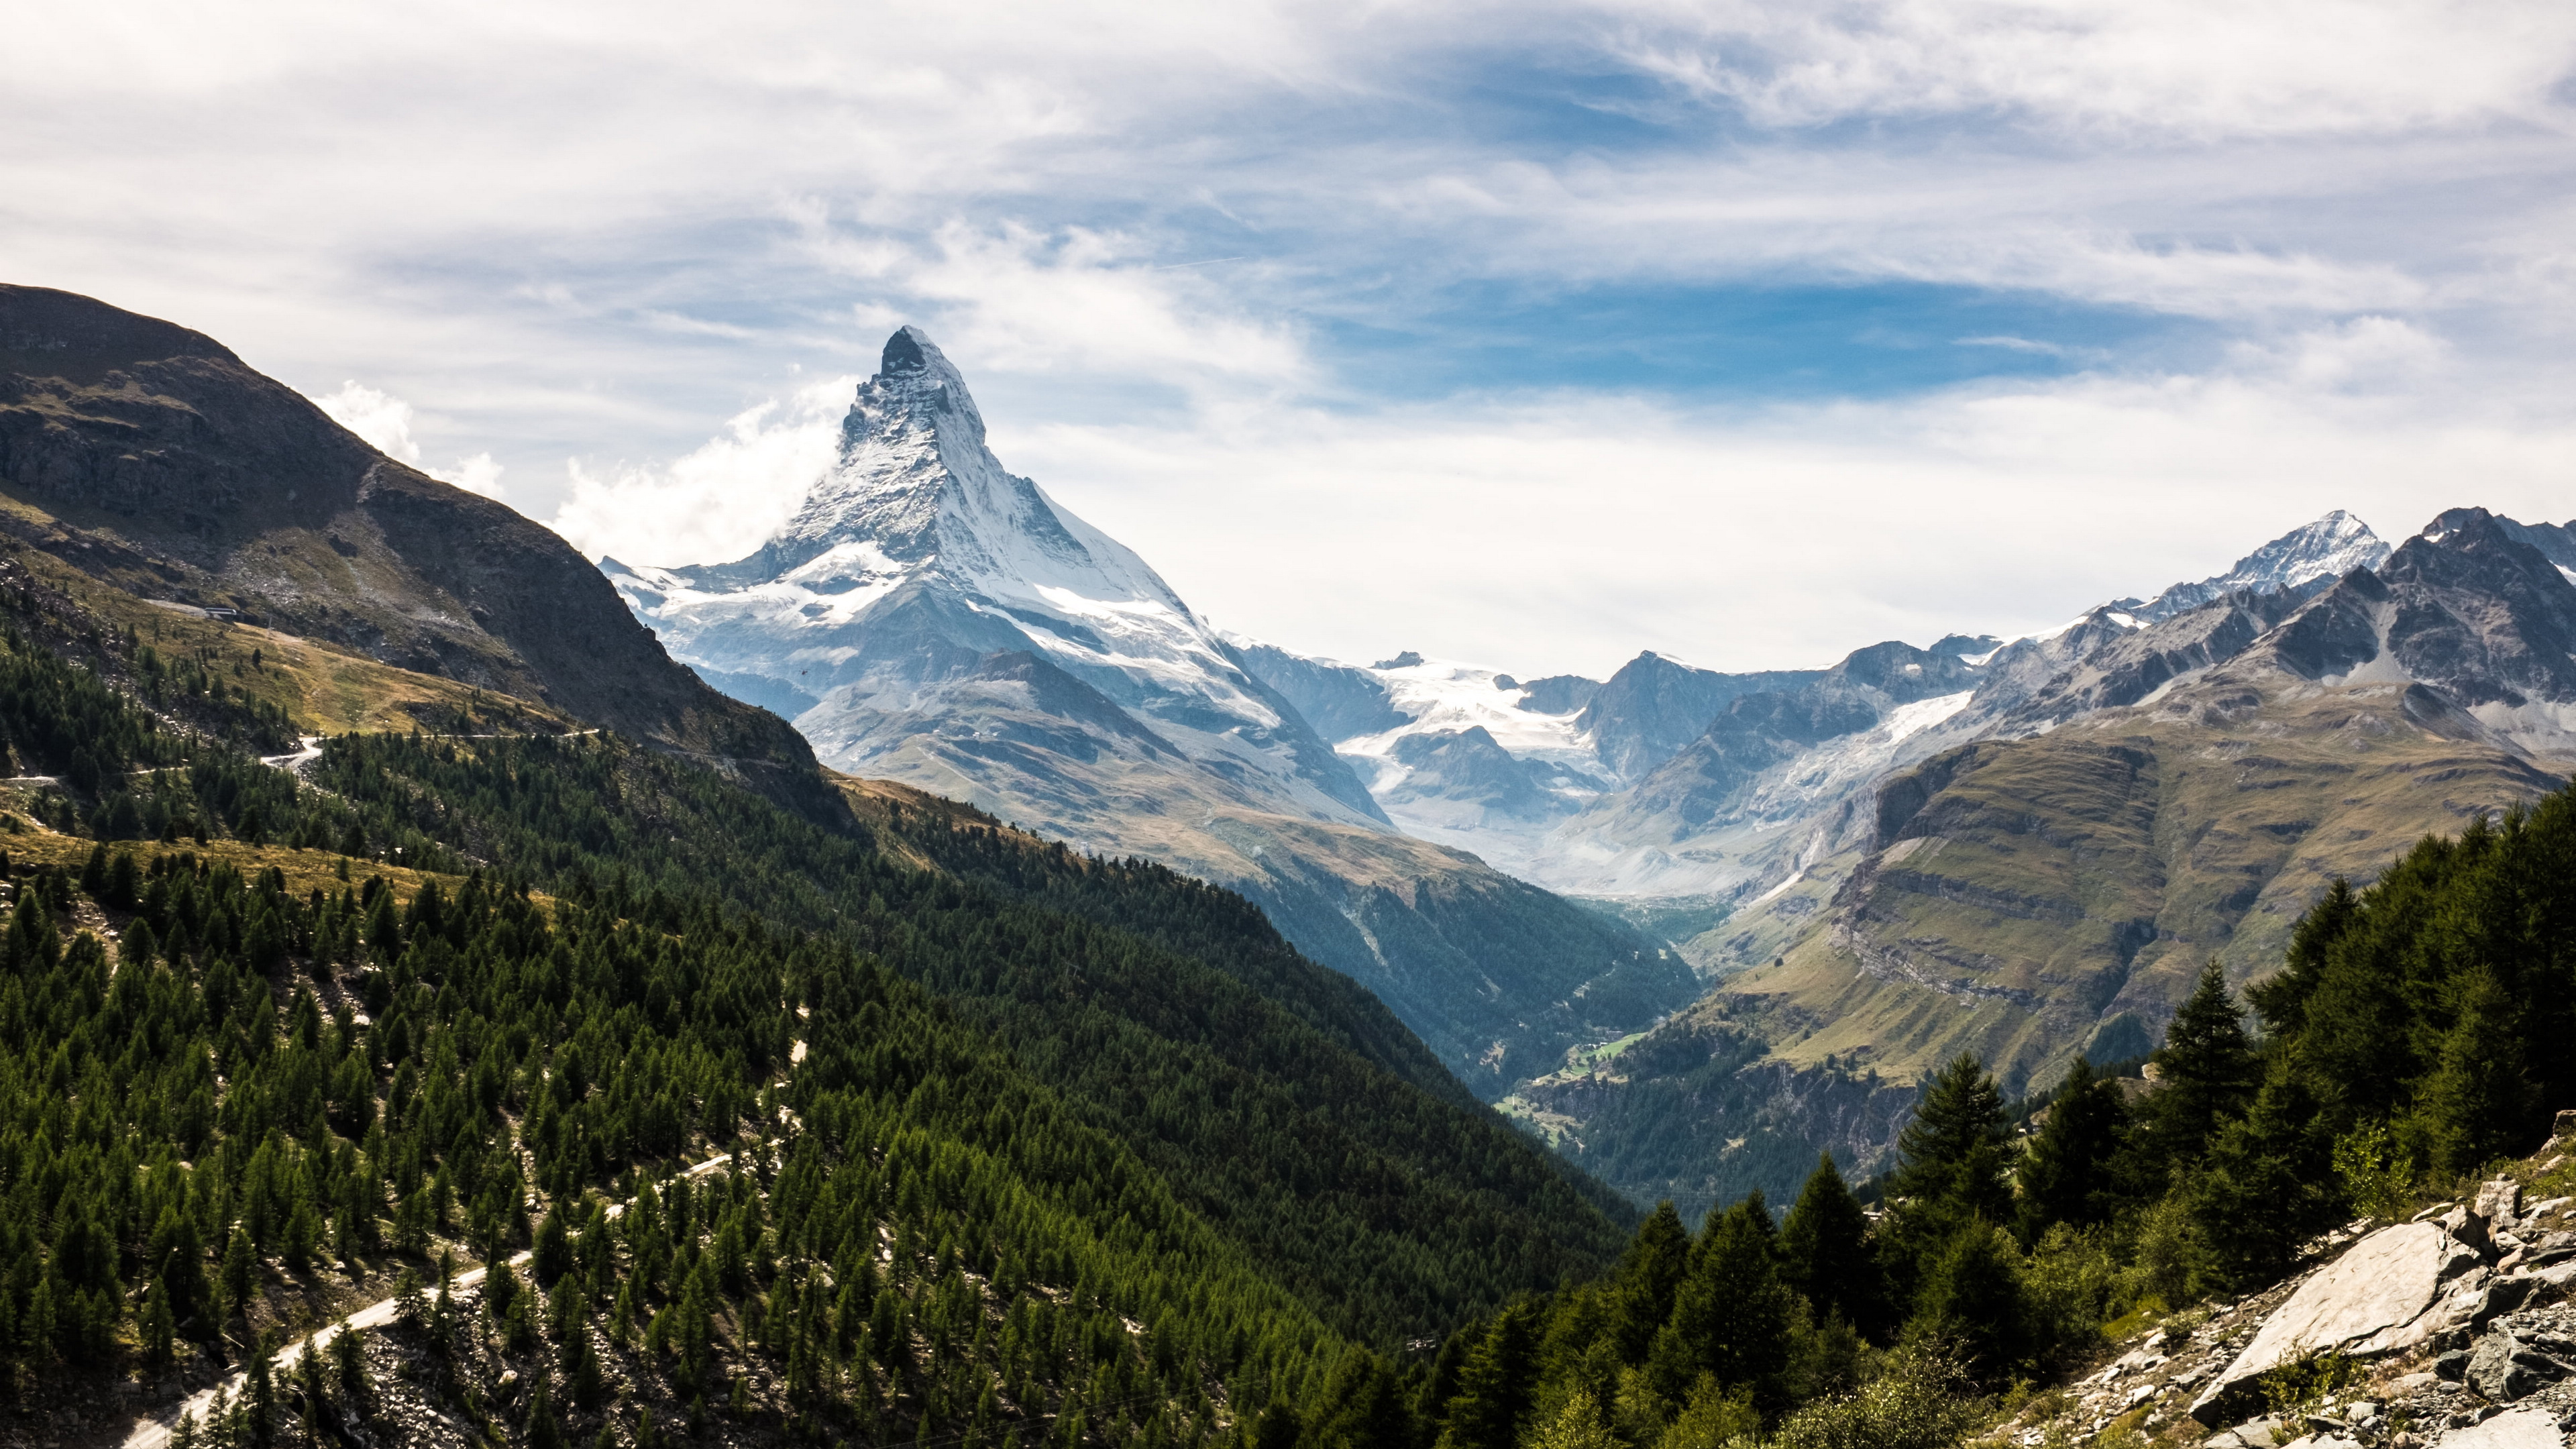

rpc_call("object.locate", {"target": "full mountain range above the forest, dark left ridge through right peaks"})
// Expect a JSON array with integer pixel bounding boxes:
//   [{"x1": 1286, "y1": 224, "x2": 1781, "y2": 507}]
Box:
[{"x1": 30, "y1": 288, "x2": 2576, "y2": 1227}]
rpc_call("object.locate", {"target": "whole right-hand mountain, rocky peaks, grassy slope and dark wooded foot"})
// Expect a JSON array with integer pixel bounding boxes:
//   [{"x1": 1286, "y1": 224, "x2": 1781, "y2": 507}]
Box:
[{"x1": 1507, "y1": 508, "x2": 2576, "y2": 1199}]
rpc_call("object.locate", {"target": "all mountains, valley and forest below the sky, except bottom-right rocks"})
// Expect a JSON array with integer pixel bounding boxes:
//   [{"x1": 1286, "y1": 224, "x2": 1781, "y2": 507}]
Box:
[{"x1": 15, "y1": 286, "x2": 2576, "y2": 1449}]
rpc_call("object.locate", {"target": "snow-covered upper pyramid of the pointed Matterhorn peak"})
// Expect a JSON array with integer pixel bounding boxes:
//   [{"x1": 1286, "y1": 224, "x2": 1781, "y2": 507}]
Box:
[{"x1": 603, "y1": 327, "x2": 1383, "y2": 835}]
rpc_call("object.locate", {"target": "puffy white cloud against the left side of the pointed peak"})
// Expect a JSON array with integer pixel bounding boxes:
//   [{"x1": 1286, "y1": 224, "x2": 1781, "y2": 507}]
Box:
[{"x1": 551, "y1": 376, "x2": 858, "y2": 565}]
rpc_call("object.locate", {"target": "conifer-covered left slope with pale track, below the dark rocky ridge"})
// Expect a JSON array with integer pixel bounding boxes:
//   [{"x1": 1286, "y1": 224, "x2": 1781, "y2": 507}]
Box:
[{"x1": 0, "y1": 580, "x2": 1615, "y2": 1444}]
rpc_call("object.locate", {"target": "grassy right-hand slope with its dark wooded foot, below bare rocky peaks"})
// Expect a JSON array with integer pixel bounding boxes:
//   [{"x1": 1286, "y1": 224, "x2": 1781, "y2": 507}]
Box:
[{"x1": 1507, "y1": 665, "x2": 2563, "y2": 1204}]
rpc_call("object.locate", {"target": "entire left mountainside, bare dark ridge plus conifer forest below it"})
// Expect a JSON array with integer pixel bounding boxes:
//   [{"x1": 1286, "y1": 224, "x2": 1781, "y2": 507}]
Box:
[{"x1": 0, "y1": 276, "x2": 1677, "y2": 1444}]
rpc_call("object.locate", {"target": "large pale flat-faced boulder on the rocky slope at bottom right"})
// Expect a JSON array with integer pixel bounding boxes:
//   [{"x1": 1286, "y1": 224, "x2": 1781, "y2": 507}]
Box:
[{"x1": 2190, "y1": 1222, "x2": 2483, "y2": 1426}]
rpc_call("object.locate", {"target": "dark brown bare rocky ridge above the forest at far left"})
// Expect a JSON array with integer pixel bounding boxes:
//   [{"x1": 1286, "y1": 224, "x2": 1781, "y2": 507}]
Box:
[{"x1": 0, "y1": 286, "x2": 812, "y2": 779}]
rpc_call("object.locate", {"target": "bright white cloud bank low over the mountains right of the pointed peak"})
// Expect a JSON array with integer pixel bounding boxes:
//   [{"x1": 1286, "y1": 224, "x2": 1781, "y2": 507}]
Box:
[{"x1": 1002, "y1": 322, "x2": 2576, "y2": 678}]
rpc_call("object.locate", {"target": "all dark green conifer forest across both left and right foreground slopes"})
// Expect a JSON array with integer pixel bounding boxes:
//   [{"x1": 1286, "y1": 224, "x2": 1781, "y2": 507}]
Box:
[{"x1": 0, "y1": 564, "x2": 2576, "y2": 1449}]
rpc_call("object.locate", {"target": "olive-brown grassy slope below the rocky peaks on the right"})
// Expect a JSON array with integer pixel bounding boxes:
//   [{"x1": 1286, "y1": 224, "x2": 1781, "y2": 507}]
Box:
[{"x1": 1723, "y1": 670, "x2": 2566, "y2": 1091}]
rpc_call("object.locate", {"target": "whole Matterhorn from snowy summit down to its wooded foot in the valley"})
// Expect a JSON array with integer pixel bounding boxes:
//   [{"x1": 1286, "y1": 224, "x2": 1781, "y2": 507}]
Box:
[{"x1": 603, "y1": 327, "x2": 1695, "y2": 1095}]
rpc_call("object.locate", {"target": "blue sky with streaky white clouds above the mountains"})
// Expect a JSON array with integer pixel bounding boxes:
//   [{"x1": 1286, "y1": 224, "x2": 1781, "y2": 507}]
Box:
[{"x1": 0, "y1": 0, "x2": 2576, "y2": 678}]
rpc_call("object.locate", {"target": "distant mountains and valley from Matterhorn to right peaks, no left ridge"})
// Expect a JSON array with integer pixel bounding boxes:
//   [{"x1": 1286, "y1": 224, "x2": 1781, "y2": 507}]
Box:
[{"x1": 603, "y1": 327, "x2": 2576, "y2": 1212}]
